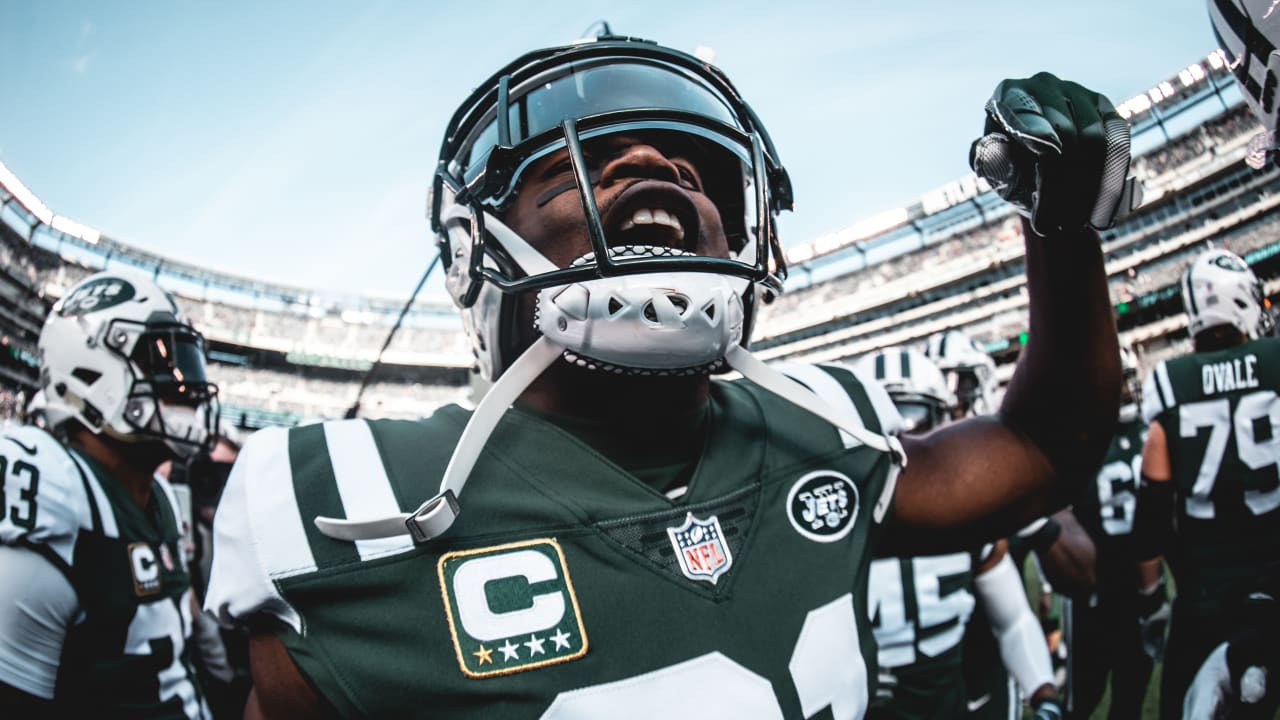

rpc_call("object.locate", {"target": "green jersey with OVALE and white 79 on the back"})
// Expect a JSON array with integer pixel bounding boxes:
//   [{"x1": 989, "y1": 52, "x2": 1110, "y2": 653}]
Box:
[{"x1": 1143, "y1": 338, "x2": 1280, "y2": 612}]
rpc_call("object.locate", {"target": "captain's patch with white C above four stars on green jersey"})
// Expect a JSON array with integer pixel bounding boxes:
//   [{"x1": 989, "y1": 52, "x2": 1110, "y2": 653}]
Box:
[{"x1": 436, "y1": 538, "x2": 586, "y2": 678}]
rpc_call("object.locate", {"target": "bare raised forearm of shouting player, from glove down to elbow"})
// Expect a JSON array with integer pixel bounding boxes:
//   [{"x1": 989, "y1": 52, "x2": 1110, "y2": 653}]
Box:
[{"x1": 1001, "y1": 220, "x2": 1121, "y2": 499}]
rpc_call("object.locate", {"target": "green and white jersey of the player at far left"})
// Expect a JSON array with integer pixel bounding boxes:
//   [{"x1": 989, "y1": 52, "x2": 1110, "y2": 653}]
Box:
[{"x1": 0, "y1": 424, "x2": 209, "y2": 719}]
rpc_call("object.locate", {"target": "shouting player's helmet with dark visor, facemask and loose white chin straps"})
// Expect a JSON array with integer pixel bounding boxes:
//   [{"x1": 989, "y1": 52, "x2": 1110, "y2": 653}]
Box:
[{"x1": 315, "y1": 37, "x2": 905, "y2": 542}]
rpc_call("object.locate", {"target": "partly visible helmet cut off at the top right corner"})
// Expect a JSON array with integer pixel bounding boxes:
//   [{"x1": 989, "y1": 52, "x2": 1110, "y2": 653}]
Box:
[{"x1": 1208, "y1": 0, "x2": 1280, "y2": 169}]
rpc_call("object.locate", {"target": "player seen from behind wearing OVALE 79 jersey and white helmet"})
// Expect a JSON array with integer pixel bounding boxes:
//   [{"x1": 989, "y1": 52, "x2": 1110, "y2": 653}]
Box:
[{"x1": 1133, "y1": 243, "x2": 1280, "y2": 717}]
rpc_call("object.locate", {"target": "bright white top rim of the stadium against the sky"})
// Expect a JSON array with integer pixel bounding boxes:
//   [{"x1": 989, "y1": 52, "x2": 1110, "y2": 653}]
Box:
[{"x1": 0, "y1": 50, "x2": 1240, "y2": 319}]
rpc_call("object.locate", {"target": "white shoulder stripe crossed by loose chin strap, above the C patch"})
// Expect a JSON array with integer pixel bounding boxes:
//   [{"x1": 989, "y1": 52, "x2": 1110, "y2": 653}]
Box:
[{"x1": 323, "y1": 420, "x2": 413, "y2": 560}]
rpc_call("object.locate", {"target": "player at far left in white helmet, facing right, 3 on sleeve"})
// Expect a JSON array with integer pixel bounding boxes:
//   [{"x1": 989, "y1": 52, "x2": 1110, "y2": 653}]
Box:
[{"x1": 0, "y1": 272, "x2": 216, "y2": 717}]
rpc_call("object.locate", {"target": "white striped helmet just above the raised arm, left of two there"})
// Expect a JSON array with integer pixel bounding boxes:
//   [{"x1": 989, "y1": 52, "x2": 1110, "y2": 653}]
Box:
[{"x1": 856, "y1": 347, "x2": 956, "y2": 433}]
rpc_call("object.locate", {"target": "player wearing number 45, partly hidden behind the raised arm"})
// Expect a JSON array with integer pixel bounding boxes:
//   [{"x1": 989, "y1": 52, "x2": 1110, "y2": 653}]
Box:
[{"x1": 856, "y1": 347, "x2": 1062, "y2": 720}]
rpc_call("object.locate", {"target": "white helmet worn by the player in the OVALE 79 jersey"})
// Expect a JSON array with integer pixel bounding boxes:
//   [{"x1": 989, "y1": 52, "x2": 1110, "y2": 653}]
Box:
[{"x1": 1183, "y1": 249, "x2": 1275, "y2": 340}]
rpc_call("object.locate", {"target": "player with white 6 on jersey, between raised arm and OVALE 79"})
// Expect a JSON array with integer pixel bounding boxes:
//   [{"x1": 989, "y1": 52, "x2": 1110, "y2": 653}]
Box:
[{"x1": 1068, "y1": 347, "x2": 1152, "y2": 720}]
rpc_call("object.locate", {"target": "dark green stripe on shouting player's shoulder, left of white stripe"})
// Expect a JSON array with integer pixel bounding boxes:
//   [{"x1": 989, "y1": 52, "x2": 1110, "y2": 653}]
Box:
[{"x1": 289, "y1": 424, "x2": 360, "y2": 568}]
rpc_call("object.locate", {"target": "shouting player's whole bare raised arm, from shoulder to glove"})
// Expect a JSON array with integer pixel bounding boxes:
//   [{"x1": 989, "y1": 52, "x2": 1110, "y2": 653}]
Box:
[{"x1": 882, "y1": 215, "x2": 1120, "y2": 555}]
